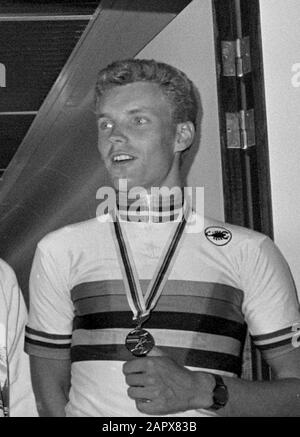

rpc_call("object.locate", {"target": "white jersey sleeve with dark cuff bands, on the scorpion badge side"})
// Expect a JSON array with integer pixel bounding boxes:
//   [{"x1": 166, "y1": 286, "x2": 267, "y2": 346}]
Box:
[{"x1": 240, "y1": 237, "x2": 300, "y2": 359}]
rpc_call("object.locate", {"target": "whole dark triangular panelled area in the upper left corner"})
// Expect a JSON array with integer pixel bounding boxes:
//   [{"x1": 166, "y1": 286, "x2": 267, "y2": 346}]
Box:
[{"x1": 0, "y1": 0, "x2": 100, "y2": 179}]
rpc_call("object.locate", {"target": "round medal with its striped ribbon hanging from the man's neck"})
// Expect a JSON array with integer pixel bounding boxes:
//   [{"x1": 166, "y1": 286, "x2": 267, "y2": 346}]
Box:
[{"x1": 113, "y1": 199, "x2": 187, "y2": 357}]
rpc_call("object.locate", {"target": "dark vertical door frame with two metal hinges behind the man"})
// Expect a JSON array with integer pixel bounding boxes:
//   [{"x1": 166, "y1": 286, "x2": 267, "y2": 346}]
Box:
[{"x1": 212, "y1": 0, "x2": 273, "y2": 380}]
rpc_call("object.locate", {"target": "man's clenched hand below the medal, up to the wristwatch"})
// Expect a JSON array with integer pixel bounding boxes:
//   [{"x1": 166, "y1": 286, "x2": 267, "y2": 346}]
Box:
[{"x1": 123, "y1": 350, "x2": 215, "y2": 415}]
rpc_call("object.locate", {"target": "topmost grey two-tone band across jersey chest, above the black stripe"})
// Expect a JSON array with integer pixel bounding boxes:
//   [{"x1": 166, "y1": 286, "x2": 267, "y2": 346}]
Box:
[{"x1": 71, "y1": 281, "x2": 244, "y2": 324}]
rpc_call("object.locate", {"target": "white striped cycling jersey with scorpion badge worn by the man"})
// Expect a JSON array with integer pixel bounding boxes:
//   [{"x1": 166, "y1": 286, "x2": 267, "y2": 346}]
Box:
[{"x1": 26, "y1": 210, "x2": 300, "y2": 416}]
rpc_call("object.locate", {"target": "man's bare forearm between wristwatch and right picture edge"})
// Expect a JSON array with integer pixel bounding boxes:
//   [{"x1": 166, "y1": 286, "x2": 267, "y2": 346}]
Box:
[{"x1": 218, "y1": 377, "x2": 300, "y2": 417}]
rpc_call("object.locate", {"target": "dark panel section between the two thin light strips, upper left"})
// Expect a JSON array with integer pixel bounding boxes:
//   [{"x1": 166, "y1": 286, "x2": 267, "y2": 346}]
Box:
[{"x1": 0, "y1": 20, "x2": 87, "y2": 112}]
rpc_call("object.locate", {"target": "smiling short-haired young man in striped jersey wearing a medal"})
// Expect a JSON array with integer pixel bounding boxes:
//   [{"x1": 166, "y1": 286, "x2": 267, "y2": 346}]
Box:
[{"x1": 27, "y1": 60, "x2": 300, "y2": 416}]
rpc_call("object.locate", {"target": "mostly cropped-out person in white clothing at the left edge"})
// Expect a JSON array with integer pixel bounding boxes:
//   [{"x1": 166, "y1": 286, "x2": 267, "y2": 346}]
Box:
[{"x1": 0, "y1": 260, "x2": 37, "y2": 417}]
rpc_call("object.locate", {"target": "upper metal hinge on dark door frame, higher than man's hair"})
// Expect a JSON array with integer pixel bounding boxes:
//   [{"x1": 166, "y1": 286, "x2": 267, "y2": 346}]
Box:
[{"x1": 221, "y1": 36, "x2": 251, "y2": 77}]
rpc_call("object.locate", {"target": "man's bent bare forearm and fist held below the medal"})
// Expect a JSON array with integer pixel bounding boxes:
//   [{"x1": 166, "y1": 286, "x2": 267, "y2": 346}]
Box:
[{"x1": 123, "y1": 349, "x2": 300, "y2": 417}]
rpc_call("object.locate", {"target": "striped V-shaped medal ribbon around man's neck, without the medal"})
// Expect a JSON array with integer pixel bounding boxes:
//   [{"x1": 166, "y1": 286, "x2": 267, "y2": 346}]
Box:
[{"x1": 114, "y1": 204, "x2": 188, "y2": 326}]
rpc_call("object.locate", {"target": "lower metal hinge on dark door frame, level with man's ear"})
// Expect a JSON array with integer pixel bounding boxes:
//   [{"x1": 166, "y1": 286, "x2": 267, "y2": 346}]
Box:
[{"x1": 226, "y1": 109, "x2": 255, "y2": 150}]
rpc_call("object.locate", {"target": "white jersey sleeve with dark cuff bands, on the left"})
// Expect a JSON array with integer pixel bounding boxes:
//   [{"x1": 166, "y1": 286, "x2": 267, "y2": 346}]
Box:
[{"x1": 25, "y1": 240, "x2": 73, "y2": 359}]
